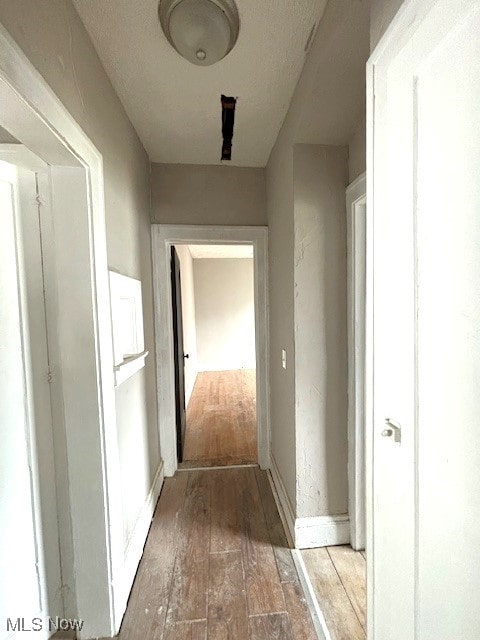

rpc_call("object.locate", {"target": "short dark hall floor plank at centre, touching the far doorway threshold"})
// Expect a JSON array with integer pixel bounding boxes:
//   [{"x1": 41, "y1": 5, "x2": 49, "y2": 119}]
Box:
[{"x1": 209, "y1": 469, "x2": 244, "y2": 553}]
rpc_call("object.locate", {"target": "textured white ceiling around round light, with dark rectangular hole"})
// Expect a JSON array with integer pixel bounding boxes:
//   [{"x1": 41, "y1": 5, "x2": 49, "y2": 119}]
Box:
[{"x1": 74, "y1": 0, "x2": 326, "y2": 167}]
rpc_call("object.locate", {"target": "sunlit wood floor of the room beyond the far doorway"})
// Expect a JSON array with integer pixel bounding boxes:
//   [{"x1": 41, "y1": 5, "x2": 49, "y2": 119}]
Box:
[{"x1": 182, "y1": 369, "x2": 257, "y2": 468}]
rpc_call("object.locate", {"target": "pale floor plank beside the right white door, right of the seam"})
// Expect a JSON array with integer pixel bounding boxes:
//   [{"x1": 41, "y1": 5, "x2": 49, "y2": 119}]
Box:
[{"x1": 328, "y1": 545, "x2": 367, "y2": 631}]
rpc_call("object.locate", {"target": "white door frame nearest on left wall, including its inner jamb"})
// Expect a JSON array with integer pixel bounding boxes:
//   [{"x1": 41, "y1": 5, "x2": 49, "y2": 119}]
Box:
[{"x1": 0, "y1": 24, "x2": 125, "y2": 638}]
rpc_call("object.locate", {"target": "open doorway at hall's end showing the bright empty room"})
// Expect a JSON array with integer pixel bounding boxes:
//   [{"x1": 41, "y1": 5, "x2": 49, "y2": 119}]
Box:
[{"x1": 171, "y1": 244, "x2": 258, "y2": 468}]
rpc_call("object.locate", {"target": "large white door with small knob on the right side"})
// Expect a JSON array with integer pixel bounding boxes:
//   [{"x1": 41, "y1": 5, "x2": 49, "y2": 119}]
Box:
[{"x1": 368, "y1": 0, "x2": 480, "y2": 640}]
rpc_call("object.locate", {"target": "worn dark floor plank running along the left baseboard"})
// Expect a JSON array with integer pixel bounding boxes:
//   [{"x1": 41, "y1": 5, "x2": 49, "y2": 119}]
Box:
[{"x1": 119, "y1": 475, "x2": 188, "y2": 640}]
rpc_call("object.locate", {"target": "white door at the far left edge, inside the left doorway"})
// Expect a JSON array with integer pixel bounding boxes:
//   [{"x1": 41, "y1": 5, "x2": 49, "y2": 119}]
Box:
[{"x1": 0, "y1": 162, "x2": 63, "y2": 640}]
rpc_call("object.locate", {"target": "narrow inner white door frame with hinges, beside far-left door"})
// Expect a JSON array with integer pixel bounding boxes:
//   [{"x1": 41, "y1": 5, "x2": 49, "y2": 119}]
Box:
[{"x1": 0, "y1": 155, "x2": 65, "y2": 637}]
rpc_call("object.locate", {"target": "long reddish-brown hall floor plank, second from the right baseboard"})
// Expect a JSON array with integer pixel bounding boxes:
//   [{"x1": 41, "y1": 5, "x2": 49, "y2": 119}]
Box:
[{"x1": 239, "y1": 469, "x2": 285, "y2": 614}]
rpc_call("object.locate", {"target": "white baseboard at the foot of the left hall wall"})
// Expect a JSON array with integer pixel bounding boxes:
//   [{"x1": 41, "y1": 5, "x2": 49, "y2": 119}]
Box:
[{"x1": 124, "y1": 462, "x2": 165, "y2": 591}]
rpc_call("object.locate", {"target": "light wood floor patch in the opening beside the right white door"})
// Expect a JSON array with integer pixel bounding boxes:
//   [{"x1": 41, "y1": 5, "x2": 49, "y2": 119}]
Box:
[{"x1": 302, "y1": 546, "x2": 367, "y2": 640}]
